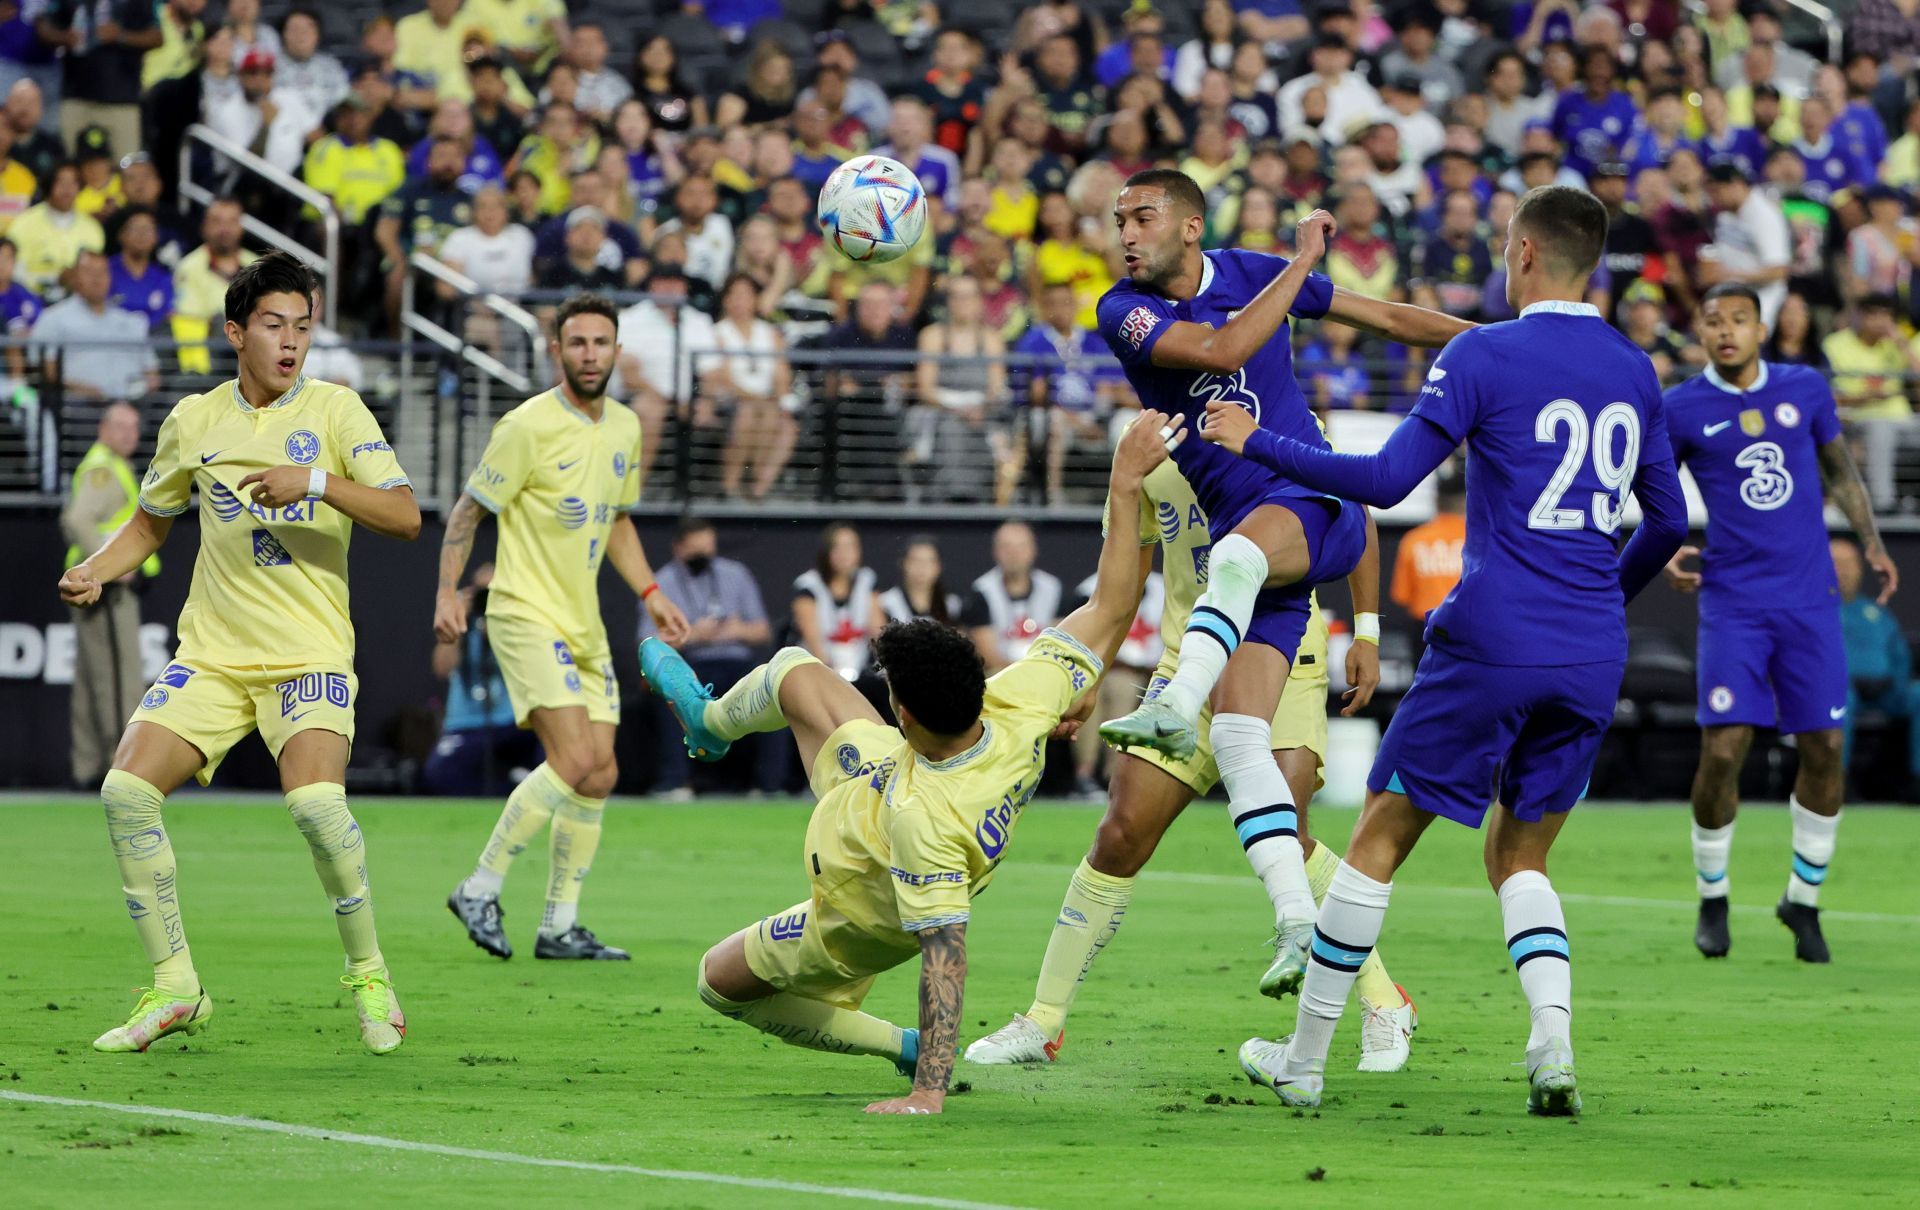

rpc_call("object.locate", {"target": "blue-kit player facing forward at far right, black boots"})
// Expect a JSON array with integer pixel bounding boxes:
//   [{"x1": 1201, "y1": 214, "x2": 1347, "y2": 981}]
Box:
[{"x1": 1667, "y1": 282, "x2": 1899, "y2": 962}]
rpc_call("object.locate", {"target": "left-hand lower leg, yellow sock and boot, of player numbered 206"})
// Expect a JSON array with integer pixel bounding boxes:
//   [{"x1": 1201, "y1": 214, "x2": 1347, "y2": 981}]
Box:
[{"x1": 94, "y1": 768, "x2": 213, "y2": 1051}]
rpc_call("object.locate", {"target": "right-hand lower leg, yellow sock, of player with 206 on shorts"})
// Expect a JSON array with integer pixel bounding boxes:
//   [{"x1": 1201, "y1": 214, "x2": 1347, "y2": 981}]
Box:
[{"x1": 280, "y1": 783, "x2": 407, "y2": 1054}]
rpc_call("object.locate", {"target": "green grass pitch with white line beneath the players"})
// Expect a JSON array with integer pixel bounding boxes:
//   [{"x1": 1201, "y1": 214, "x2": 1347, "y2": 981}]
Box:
[{"x1": 0, "y1": 799, "x2": 1920, "y2": 1208}]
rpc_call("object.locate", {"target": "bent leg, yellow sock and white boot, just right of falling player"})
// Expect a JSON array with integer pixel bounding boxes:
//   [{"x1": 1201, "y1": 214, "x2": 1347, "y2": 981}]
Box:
[{"x1": 966, "y1": 753, "x2": 1194, "y2": 1064}]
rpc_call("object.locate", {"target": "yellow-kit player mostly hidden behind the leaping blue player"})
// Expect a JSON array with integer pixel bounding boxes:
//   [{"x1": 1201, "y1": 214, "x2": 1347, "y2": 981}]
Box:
[{"x1": 966, "y1": 434, "x2": 1417, "y2": 1072}]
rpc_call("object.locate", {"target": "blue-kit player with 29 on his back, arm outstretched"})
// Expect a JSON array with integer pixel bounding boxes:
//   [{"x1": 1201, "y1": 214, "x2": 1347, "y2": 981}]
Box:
[{"x1": 1200, "y1": 186, "x2": 1686, "y2": 1114}]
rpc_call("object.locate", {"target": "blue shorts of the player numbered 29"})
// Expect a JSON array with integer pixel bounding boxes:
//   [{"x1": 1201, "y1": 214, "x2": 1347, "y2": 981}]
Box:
[{"x1": 1367, "y1": 647, "x2": 1626, "y2": 828}]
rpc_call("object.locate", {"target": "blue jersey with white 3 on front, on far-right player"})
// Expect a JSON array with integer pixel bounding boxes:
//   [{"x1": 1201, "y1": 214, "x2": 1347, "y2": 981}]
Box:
[{"x1": 1667, "y1": 361, "x2": 1839, "y2": 611}]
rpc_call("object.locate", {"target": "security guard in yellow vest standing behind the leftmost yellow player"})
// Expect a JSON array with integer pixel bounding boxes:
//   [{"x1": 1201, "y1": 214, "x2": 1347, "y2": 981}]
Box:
[{"x1": 60, "y1": 403, "x2": 159, "y2": 786}]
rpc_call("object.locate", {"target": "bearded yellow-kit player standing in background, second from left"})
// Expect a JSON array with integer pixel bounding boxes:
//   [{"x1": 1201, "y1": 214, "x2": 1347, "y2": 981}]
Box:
[{"x1": 434, "y1": 294, "x2": 687, "y2": 960}]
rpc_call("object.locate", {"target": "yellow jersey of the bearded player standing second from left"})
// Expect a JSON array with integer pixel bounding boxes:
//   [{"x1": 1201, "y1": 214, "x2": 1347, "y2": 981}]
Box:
[{"x1": 467, "y1": 388, "x2": 639, "y2": 655}]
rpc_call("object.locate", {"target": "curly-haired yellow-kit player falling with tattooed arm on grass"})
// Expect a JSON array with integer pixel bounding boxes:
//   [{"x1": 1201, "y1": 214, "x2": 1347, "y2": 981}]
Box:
[{"x1": 639, "y1": 411, "x2": 1185, "y2": 1114}]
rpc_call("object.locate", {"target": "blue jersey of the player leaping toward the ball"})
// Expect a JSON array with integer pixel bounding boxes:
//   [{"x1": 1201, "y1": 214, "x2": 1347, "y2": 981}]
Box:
[{"x1": 1100, "y1": 250, "x2": 1332, "y2": 540}]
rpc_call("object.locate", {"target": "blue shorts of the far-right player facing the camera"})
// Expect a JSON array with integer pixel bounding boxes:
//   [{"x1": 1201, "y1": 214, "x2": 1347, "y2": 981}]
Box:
[{"x1": 1697, "y1": 603, "x2": 1847, "y2": 734}]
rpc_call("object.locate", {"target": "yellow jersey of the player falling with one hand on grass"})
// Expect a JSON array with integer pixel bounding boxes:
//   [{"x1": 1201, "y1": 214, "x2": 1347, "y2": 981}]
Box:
[{"x1": 806, "y1": 630, "x2": 1100, "y2": 970}]
